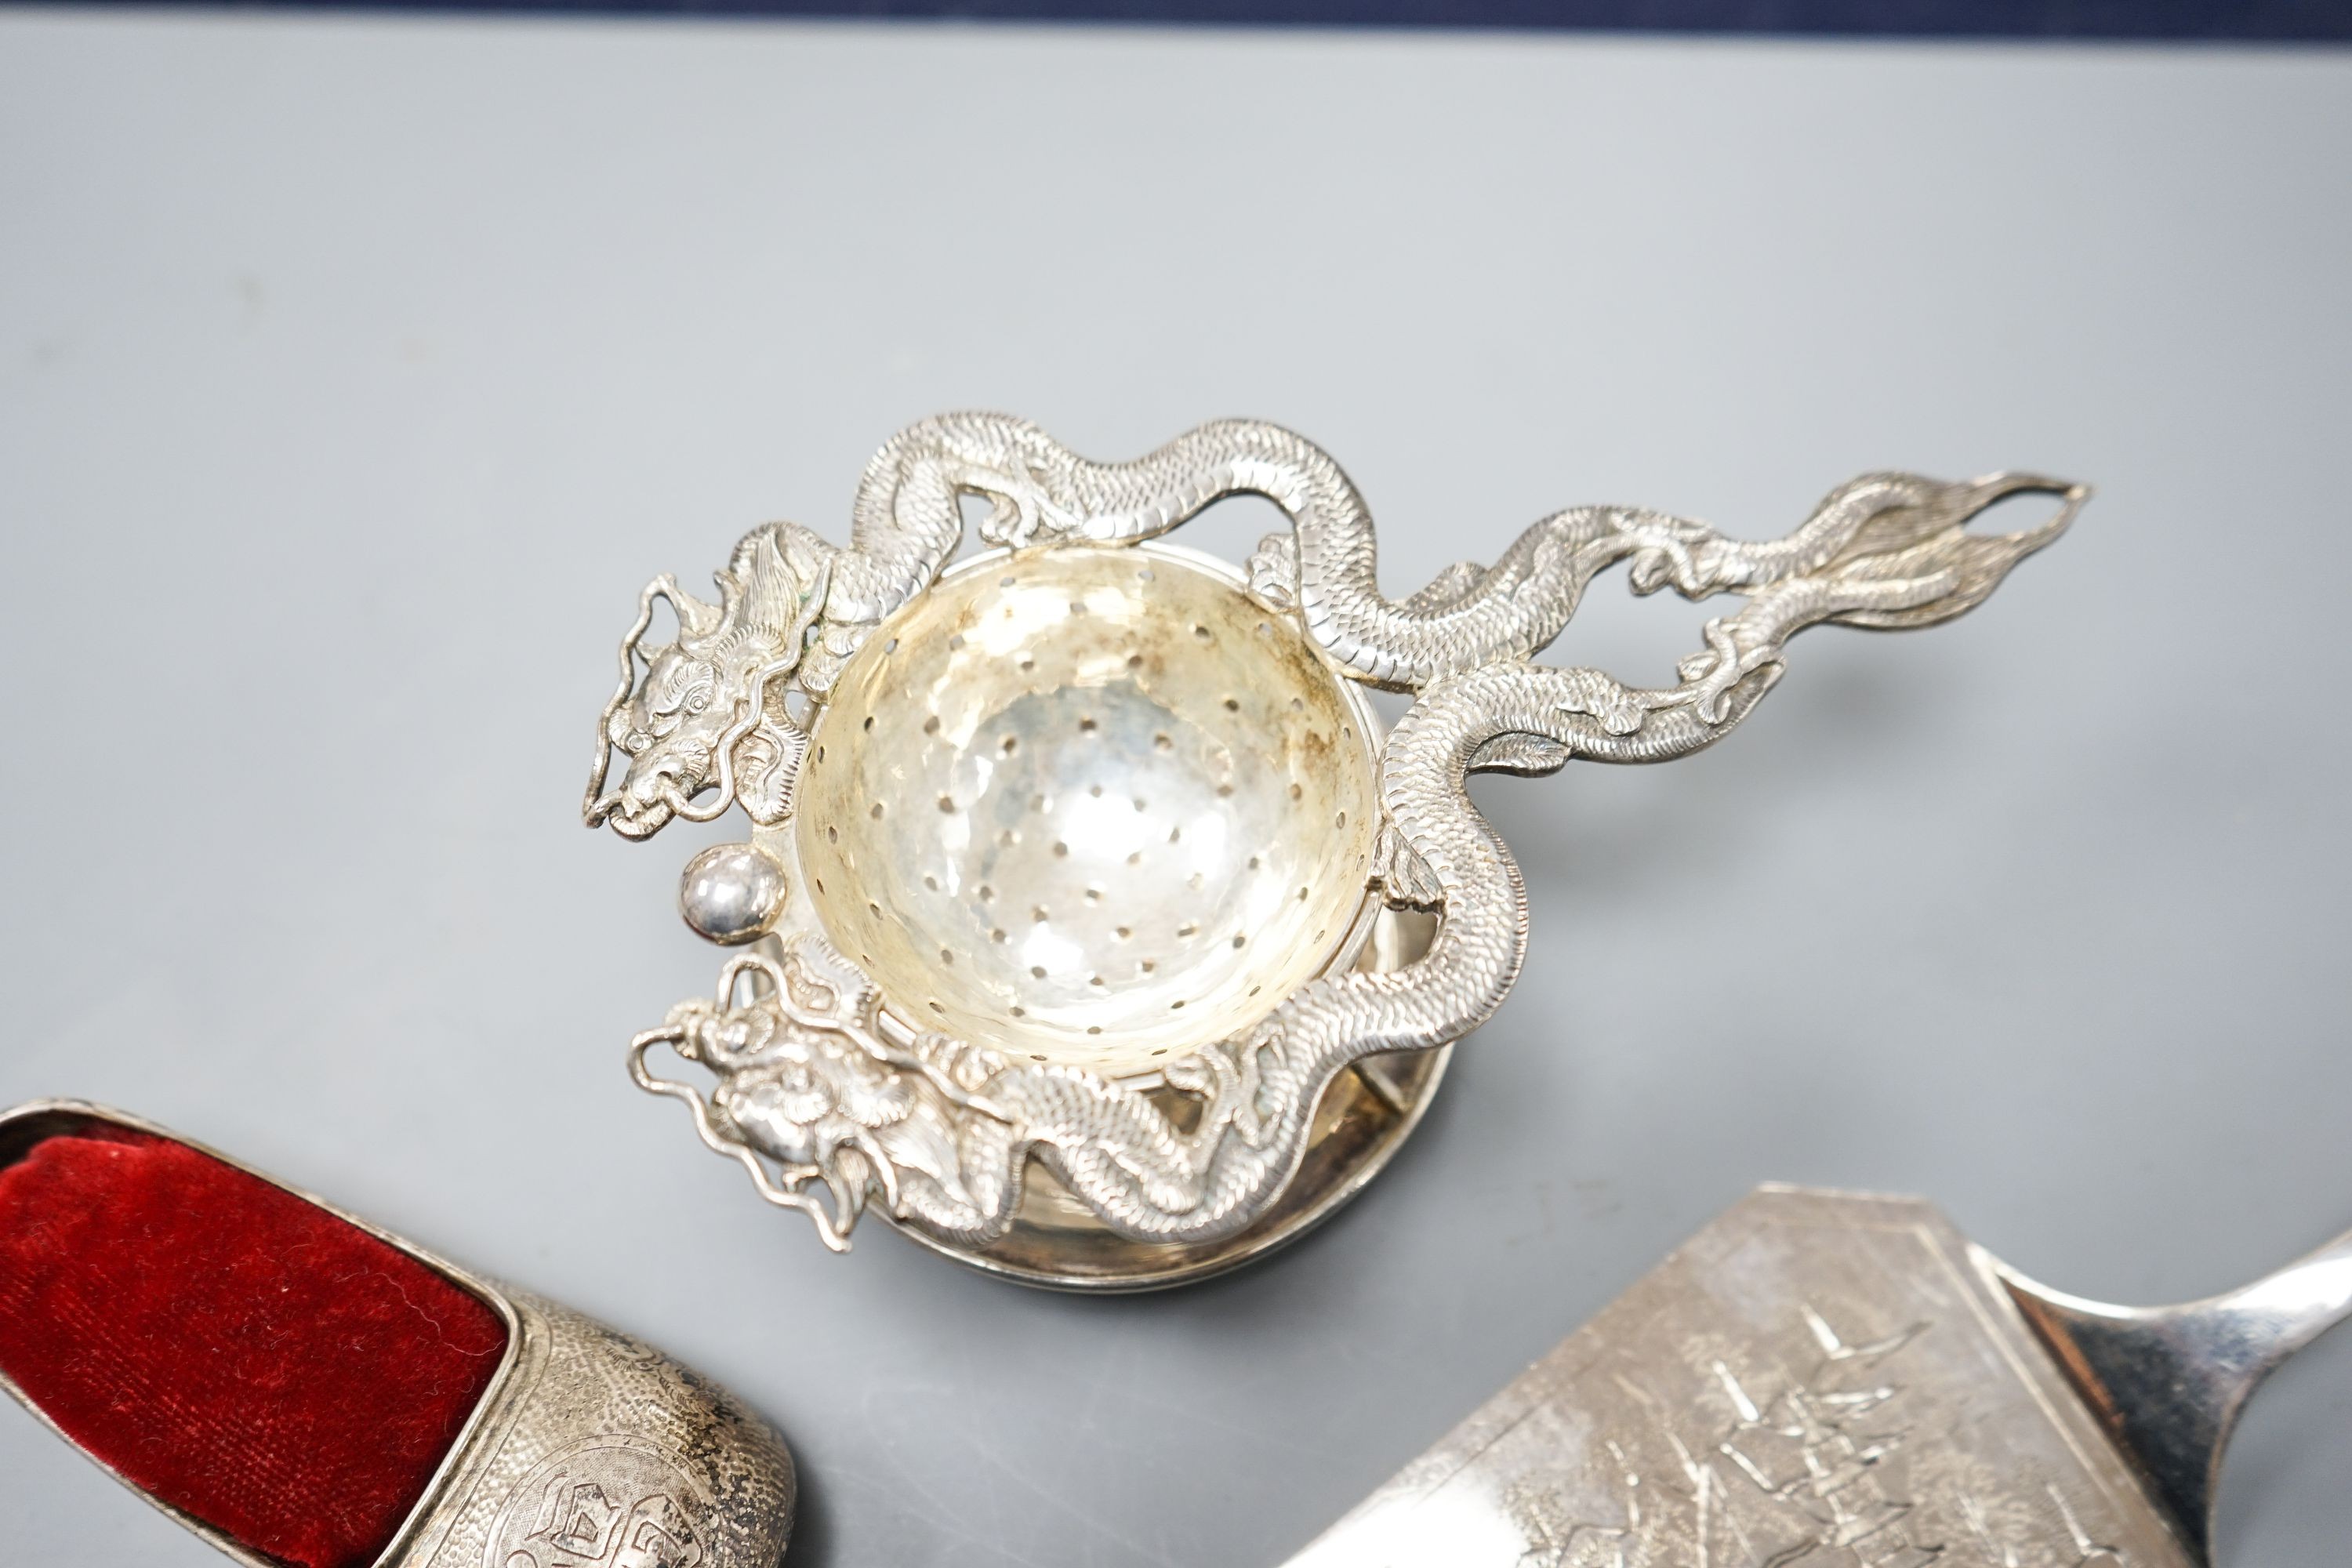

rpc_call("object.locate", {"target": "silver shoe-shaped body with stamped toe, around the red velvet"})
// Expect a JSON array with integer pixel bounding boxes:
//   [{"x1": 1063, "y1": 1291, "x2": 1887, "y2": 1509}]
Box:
[{"x1": 0, "y1": 1100, "x2": 795, "y2": 1568}]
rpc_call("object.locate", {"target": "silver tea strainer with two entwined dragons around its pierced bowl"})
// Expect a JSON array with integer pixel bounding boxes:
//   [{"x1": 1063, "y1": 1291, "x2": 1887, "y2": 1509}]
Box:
[{"x1": 583, "y1": 414, "x2": 2086, "y2": 1283}]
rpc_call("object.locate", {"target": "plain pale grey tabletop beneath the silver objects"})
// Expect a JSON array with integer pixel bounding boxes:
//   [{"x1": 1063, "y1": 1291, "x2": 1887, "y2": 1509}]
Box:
[{"x1": 0, "y1": 12, "x2": 2352, "y2": 1568}]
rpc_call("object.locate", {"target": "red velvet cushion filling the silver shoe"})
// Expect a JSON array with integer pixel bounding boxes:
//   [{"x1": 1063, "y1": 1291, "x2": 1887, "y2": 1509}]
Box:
[{"x1": 0, "y1": 1119, "x2": 508, "y2": 1568}]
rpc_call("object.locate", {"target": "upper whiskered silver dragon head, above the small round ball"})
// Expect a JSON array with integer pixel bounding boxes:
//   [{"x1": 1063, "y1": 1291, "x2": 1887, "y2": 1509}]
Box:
[{"x1": 581, "y1": 522, "x2": 833, "y2": 839}]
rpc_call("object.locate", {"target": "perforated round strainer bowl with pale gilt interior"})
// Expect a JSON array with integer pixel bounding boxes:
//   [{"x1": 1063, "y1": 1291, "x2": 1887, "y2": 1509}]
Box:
[{"x1": 795, "y1": 546, "x2": 1378, "y2": 1072}]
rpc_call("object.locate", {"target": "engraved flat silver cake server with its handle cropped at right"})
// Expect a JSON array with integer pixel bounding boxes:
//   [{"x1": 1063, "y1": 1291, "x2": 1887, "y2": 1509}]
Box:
[{"x1": 1289, "y1": 1187, "x2": 2352, "y2": 1568}]
